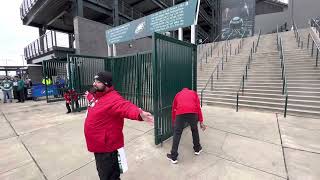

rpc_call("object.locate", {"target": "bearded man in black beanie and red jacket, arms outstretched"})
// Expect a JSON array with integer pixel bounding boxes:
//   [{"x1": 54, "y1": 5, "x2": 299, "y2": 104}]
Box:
[{"x1": 84, "y1": 72, "x2": 153, "y2": 180}]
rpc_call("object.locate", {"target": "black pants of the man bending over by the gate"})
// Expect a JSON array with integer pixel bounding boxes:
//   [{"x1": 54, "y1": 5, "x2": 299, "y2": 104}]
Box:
[{"x1": 171, "y1": 114, "x2": 202, "y2": 159}]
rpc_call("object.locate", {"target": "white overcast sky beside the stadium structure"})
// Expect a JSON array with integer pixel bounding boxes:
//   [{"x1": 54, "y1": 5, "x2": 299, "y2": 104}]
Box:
[{"x1": 0, "y1": 0, "x2": 288, "y2": 66}]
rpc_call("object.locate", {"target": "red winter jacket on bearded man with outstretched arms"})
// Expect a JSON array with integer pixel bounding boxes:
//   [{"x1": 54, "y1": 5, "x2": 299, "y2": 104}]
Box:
[{"x1": 84, "y1": 87, "x2": 142, "y2": 153}]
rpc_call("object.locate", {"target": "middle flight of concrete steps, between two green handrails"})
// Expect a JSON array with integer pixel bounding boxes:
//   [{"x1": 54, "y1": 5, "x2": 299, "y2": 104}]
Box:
[{"x1": 239, "y1": 34, "x2": 285, "y2": 112}]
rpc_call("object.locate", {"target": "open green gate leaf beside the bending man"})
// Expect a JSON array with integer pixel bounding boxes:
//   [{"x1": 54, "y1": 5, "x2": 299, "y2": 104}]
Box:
[{"x1": 152, "y1": 33, "x2": 197, "y2": 144}]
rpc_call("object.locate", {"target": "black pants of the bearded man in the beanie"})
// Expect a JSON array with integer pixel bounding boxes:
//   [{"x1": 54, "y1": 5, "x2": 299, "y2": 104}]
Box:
[{"x1": 94, "y1": 151, "x2": 120, "y2": 180}]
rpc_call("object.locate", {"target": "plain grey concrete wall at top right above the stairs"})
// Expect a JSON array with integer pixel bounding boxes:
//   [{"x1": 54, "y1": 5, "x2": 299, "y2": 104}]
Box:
[{"x1": 288, "y1": 0, "x2": 320, "y2": 29}]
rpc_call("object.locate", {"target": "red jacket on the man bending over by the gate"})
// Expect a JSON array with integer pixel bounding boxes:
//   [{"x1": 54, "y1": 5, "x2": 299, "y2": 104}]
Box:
[{"x1": 172, "y1": 88, "x2": 203, "y2": 124}]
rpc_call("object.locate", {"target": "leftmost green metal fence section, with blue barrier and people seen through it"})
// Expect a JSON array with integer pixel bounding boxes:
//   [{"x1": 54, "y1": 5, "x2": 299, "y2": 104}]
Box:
[{"x1": 42, "y1": 60, "x2": 68, "y2": 103}]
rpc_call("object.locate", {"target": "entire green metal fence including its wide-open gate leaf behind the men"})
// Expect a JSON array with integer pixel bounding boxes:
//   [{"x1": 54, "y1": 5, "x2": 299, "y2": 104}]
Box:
[{"x1": 68, "y1": 33, "x2": 197, "y2": 144}]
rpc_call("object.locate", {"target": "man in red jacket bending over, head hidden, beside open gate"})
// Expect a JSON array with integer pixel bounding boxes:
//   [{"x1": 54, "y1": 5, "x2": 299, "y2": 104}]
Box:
[{"x1": 167, "y1": 88, "x2": 206, "y2": 164}]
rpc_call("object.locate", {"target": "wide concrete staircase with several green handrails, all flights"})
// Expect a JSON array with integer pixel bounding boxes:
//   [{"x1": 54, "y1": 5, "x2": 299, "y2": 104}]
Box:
[{"x1": 198, "y1": 29, "x2": 320, "y2": 117}]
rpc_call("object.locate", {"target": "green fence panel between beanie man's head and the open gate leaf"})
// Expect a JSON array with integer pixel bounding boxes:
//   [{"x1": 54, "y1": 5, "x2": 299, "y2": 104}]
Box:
[{"x1": 109, "y1": 52, "x2": 153, "y2": 112}]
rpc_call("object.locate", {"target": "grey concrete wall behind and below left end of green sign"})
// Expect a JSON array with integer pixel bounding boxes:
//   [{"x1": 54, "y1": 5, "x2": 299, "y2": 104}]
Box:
[{"x1": 74, "y1": 17, "x2": 152, "y2": 57}]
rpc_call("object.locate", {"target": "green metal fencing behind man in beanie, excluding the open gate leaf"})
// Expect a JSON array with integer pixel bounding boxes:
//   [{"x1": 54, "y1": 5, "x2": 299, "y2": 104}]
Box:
[{"x1": 68, "y1": 52, "x2": 153, "y2": 112}]
